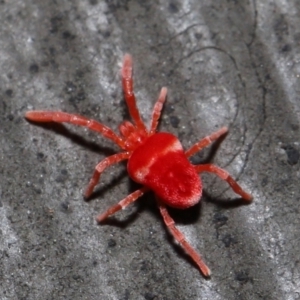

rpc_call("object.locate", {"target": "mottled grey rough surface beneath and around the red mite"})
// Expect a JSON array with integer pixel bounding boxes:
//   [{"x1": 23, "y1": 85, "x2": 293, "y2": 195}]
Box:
[{"x1": 0, "y1": 0, "x2": 300, "y2": 300}]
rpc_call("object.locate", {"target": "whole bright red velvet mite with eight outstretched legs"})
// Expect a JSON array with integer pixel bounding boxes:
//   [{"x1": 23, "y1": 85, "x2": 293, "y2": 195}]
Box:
[{"x1": 25, "y1": 54, "x2": 252, "y2": 276}]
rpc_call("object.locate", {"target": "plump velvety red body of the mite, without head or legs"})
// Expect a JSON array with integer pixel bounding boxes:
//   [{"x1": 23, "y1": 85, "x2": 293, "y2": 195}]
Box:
[{"x1": 127, "y1": 132, "x2": 202, "y2": 209}]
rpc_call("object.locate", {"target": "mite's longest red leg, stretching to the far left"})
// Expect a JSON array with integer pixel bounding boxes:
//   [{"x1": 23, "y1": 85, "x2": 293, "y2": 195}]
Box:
[{"x1": 25, "y1": 110, "x2": 125, "y2": 149}]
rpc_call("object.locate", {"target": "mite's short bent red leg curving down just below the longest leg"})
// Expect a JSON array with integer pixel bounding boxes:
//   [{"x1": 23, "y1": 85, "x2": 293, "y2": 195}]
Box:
[{"x1": 84, "y1": 152, "x2": 130, "y2": 199}]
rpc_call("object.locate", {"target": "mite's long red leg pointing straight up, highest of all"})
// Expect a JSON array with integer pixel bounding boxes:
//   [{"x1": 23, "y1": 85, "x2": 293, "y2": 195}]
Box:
[{"x1": 122, "y1": 54, "x2": 146, "y2": 131}]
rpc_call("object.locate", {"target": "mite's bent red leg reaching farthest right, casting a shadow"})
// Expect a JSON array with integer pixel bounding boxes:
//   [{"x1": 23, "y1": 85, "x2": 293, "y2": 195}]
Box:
[{"x1": 195, "y1": 164, "x2": 252, "y2": 201}]
